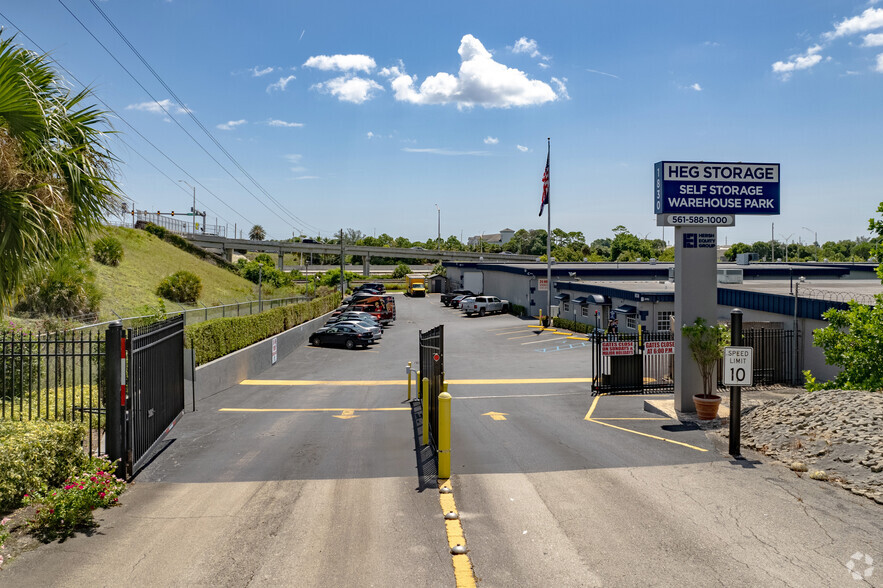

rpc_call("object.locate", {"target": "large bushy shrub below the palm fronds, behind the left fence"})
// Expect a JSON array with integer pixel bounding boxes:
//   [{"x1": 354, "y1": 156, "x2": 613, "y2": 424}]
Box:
[{"x1": 15, "y1": 250, "x2": 101, "y2": 317}]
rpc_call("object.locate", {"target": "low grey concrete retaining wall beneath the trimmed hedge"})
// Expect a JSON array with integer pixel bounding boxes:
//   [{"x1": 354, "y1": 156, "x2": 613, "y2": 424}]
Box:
[{"x1": 196, "y1": 313, "x2": 330, "y2": 400}]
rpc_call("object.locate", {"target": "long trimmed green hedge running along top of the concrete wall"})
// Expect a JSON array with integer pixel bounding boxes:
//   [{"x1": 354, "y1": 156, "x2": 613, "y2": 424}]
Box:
[{"x1": 184, "y1": 293, "x2": 340, "y2": 365}]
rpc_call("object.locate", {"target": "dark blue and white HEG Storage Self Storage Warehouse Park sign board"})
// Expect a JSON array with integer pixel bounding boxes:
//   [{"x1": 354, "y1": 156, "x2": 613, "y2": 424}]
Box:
[{"x1": 654, "y1": 161, "x2": 779, "y2": 216}]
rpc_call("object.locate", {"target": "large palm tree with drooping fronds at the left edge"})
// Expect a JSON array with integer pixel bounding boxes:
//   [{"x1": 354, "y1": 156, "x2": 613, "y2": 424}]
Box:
[{"x1": 0, "y1": 33, "x2": 119, "y2": 310}]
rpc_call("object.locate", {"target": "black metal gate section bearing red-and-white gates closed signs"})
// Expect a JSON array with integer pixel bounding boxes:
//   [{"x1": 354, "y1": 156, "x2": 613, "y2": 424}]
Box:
[{"x1": 592, "y1": 331, "x2": 674, "y2": 395}]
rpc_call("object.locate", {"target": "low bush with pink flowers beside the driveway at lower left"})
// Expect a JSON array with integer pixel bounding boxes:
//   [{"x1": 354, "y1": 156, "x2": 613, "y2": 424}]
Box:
[{"x1": 25, "y1": 458, "x2": 126, "y2": 540}]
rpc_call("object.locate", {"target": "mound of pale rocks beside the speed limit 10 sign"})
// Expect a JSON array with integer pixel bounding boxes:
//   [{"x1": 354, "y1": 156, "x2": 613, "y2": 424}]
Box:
[{"x1": 742, "y1": 390, "x2": 883, "y2": 504}]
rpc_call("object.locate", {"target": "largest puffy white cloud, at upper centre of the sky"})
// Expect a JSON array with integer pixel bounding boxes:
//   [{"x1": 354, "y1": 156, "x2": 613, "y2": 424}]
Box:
[{"x1": 380, "y1": 35, "x2": 560, "y2": 109}]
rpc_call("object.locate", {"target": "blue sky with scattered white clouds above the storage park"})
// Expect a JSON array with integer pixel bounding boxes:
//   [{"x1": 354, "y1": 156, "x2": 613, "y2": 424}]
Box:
[{"x1": 0, "y1": 0, "x2": 883, "y2": 243}]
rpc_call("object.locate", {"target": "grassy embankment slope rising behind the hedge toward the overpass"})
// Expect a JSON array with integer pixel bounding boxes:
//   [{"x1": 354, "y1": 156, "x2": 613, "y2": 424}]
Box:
[{"x1": 92, "y1": 227, "x2": 266, "y2": 320}]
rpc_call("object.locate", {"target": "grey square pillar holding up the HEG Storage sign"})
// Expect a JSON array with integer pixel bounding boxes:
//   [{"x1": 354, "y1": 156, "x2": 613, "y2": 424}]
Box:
[{"x1": 674, "y1": 226, "x2": 717, "y2": 412}]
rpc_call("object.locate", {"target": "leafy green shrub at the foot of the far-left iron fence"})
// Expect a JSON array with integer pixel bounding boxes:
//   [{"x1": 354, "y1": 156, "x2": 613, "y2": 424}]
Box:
[{"x1": 0, "y1": 420, "x2": 88, "y2": 511}]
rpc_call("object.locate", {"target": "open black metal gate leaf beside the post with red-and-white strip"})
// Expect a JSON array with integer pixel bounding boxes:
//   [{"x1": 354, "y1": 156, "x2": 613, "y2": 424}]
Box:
[{"x1": 126, "y1": 315, "x2": 184, "y2": 474}]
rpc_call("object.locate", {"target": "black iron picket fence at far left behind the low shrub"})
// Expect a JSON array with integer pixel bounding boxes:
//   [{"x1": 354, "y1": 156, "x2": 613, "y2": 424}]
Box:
[{"x1": 0, "y1": 332, "x2": 107, "y2": 455}]
